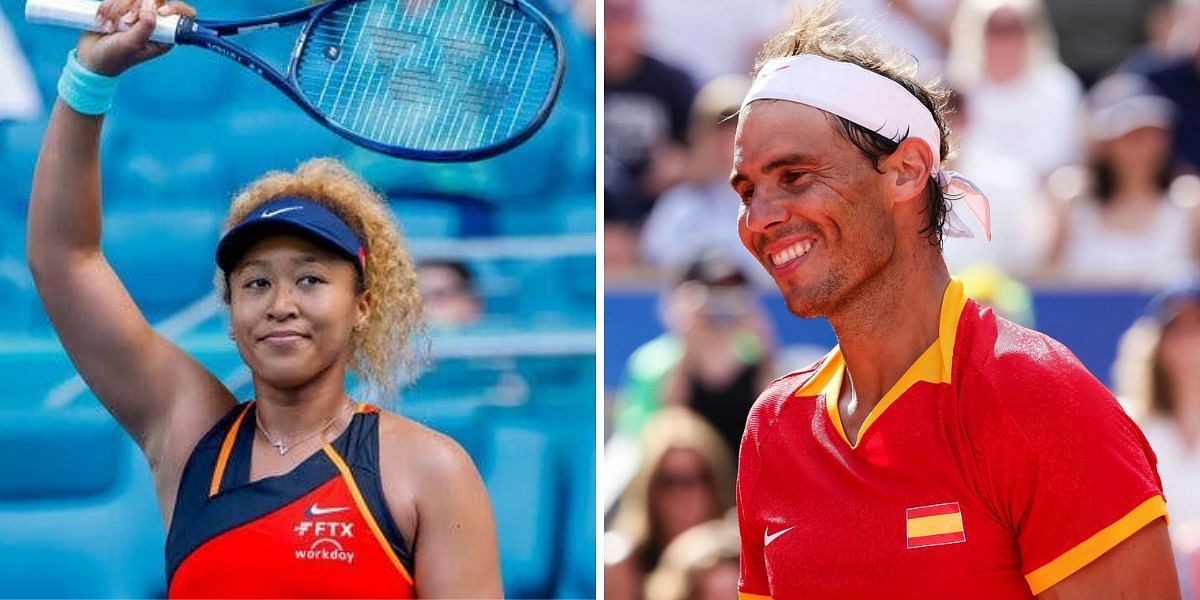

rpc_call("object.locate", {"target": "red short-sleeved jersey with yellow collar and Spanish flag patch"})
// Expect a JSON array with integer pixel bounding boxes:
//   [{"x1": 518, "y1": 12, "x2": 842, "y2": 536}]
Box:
[{"x1": 737, "y1": 281, "x2": 1166, "y2": 599}]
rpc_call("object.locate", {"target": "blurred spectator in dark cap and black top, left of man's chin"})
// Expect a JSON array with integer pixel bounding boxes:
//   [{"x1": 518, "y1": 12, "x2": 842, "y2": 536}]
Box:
[{"x1": 617, "y1": 251, "x2": 774, "y2": 449}]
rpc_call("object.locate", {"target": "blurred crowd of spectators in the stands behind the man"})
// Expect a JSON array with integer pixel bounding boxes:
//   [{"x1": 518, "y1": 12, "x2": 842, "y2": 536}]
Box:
[{"x1": 604, "y1": 0, "x2": 1200, "y2": 600}]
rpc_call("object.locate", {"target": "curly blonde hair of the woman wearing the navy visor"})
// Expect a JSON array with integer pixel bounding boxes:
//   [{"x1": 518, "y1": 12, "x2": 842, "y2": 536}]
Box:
[{"x1": 216, "y1": 158, "x2": 428, "y2": 400}]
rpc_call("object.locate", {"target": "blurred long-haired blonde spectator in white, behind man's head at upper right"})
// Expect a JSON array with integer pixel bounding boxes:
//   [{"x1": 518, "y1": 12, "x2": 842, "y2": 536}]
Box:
[{"x1": 948, "y1": 0, "x2": 1082, "y2": 178}]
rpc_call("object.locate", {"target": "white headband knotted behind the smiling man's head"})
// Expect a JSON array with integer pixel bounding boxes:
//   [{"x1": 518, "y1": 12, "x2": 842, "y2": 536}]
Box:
[{"x1": 742, "y1": 54, "x2": 991, "y2": 240}]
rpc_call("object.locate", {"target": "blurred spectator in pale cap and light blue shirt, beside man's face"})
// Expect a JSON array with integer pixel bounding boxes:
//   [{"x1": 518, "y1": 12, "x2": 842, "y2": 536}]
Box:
[{"x1": 641, "y1": 74, "x2": 766, "y2": 280}]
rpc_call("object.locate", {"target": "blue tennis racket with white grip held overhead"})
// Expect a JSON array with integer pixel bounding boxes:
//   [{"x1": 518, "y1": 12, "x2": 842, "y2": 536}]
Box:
[{"x1": 25, "y1": 0, "x2": 564, "y2": 161}]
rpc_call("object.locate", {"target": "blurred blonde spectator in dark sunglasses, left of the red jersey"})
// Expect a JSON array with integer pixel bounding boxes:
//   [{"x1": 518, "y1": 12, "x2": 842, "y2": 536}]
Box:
[{"x1": 604, "y1": 407, "x2": 733, "y2": 600}]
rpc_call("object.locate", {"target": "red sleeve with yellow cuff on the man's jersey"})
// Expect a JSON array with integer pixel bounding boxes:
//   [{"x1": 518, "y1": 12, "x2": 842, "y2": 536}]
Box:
[{"x1": 961, "y1": 325, "x2": 1165, "y2": 594}]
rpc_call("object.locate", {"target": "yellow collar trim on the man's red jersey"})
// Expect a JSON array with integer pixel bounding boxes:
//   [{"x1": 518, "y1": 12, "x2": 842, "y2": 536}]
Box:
[{"x1": 796, "y1": 277, "x2": 967, "y2": 449}]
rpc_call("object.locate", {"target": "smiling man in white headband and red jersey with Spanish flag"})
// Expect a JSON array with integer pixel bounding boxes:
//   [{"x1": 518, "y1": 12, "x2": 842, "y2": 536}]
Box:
[{"x1": 732, "y1": 6, "x2": 1180, "y2": 599}]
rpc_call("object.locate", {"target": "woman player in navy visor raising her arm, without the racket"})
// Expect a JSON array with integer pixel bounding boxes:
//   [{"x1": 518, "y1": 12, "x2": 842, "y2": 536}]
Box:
[{"x1": 28, "y1": 0, "x2": 502, "y2": 598}]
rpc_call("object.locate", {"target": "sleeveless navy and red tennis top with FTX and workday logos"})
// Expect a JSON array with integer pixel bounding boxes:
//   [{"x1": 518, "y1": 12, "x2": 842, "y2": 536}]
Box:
[{"x1": 167, "y1": 402, "x2": 415, "y2": 598}]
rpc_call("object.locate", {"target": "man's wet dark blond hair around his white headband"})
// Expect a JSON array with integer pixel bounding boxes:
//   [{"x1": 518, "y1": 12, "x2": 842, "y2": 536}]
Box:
[{"x1": 752, "y1": 0, "x2": 954, "y2": 247}]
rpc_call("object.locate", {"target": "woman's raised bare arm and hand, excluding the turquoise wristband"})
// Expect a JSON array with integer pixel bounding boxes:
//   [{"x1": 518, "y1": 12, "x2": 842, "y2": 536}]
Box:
[{"x1": 26, "y1": 0, "x2": 234, "y2": 477}]
